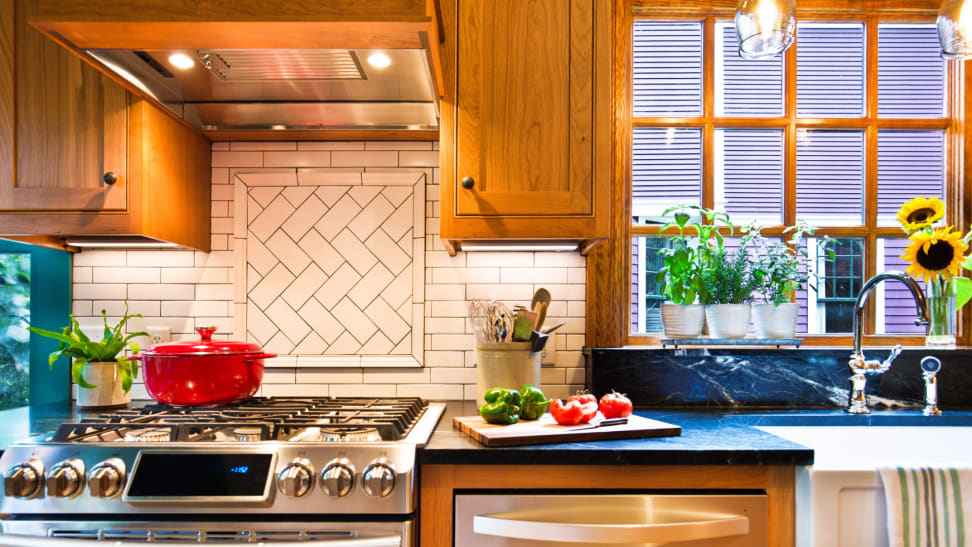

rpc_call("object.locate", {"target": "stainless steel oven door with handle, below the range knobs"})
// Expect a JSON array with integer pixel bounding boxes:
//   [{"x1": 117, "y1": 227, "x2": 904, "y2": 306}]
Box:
[{"x1": 0, "y1": 520, "x2": 414, "y2": 547}]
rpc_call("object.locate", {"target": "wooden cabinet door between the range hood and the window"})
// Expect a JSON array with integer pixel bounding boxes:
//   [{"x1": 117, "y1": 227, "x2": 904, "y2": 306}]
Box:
[{"x1": 453, "y1": 0, "x2": 594, "y2": 216}]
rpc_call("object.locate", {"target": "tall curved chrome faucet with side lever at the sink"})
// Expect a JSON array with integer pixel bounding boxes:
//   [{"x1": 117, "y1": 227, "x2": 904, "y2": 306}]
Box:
[{"x1": 847, "y1": 272, "x2": 928, "y2": 414}]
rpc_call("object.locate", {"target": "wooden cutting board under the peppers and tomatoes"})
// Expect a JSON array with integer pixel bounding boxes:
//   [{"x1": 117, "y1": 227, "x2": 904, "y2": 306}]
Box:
[{"x1": 452, "y1": 412, "x2": 682, "y2": 446}]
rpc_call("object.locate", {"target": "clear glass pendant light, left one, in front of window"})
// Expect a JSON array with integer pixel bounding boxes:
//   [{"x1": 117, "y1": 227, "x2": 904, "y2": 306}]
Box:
[{"x1": 736, "y1": 0, "x2": 796, "y2": 59}]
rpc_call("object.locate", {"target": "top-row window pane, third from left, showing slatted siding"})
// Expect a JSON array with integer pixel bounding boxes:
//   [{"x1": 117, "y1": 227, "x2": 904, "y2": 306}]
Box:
[{"x1": 796, "y1": 23, "x2": 865, "y2": 118}]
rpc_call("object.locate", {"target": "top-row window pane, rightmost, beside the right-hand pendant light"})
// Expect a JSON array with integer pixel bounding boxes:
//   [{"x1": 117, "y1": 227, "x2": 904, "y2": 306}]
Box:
[{"x1": 878, "y1": 24, "x2": 945, "y2": 118}]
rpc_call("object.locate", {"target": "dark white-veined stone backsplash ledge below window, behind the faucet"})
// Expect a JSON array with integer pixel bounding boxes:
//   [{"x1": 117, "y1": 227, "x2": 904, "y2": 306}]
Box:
[{"x1": 587, "y1": 348, "x2": 972, "y2": 411}]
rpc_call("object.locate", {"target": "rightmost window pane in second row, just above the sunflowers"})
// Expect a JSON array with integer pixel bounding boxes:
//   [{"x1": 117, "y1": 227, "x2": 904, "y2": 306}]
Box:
[{"x1": 878, "y1": 131, "x2": 945, "y2": 226}]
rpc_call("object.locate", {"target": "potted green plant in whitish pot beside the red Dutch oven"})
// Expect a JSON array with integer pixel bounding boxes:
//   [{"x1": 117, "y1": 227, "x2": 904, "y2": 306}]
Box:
[{"x1": 28, "y1": 306, "x2": 148, "y2": 408}]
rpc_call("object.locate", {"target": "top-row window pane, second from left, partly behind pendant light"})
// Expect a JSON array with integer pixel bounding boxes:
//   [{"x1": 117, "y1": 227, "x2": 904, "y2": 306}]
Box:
[{"x1": 716, "y1": 21, "x2": 783, "y2": 116}]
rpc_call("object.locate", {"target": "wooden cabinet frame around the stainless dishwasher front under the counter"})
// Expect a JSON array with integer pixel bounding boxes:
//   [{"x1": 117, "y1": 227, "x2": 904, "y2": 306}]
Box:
[{"x1": 418, "y1": 464, "x2": 796, "y2": 547}]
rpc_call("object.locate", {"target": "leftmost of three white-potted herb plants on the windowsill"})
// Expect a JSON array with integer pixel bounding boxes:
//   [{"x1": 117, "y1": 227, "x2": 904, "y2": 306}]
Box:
[{"x1": 656, "y1": 206, "x2": 732, "y2": 338}]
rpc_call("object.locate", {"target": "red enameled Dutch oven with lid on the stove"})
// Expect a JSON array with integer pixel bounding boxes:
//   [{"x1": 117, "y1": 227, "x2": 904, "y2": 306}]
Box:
[{"x1": 132, "y1": 327, "x2": 276, "y2": 406}]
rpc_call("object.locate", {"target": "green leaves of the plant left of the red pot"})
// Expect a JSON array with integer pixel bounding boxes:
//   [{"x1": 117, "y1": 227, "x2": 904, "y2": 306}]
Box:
[{"x1": 28, "y1": 304, "x2": 148, "y2": 393}]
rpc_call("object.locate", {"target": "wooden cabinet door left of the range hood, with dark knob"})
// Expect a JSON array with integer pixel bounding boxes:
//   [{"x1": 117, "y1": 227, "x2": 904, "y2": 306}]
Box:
[{"x1": 0, "y1": 0, "x2": 128, "y2": 211}]
